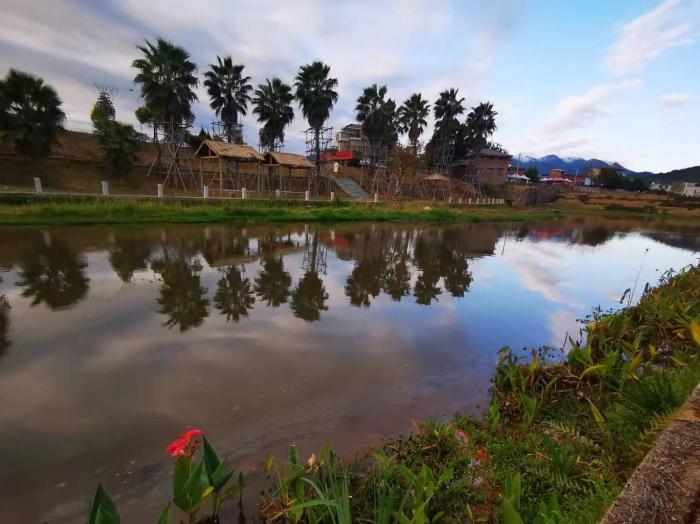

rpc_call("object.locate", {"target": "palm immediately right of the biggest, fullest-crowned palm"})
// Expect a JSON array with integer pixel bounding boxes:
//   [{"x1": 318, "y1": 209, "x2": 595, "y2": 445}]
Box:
[{"x1": 204, "y1": 56, "x2": 253, "y2": 142}]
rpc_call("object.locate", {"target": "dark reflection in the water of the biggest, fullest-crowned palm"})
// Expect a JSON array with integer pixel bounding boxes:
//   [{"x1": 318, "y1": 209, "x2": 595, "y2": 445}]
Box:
[{"x1": 152, "y1": 257, "x2": 209, "y2": 331}]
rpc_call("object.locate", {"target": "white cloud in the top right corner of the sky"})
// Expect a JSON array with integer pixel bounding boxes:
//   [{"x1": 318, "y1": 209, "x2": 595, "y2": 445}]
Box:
[{"x1": 607, "y1": 0, "x2": 698, "y2": 75}]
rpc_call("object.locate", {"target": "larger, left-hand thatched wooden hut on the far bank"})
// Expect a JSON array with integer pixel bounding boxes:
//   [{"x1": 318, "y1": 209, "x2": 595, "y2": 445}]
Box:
[{"x1": 194, "y1": 139, "x2": 267, "y2": 195}]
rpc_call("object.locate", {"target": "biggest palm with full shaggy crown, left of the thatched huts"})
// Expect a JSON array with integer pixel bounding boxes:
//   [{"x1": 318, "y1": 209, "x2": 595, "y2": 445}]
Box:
[{"x1": 132, "y1": 38, "x2": 199, "y2": 138}]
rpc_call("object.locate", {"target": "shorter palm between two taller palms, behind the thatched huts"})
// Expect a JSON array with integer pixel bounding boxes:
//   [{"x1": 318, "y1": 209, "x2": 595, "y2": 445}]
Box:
[{"x1": 253, "y1": 77, "x2": 294, "y2": 148}]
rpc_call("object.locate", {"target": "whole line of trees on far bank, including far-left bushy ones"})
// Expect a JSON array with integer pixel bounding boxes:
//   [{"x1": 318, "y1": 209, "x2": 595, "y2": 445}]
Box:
[{"x1": 0, "y1": 38, "x2": 499, "y2": 176}]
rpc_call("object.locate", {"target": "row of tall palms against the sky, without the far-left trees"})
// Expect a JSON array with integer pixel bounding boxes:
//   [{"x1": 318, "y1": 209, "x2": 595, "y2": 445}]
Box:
[{"x1": 133, "y1": 38, "x2": 497, "y2": 159}]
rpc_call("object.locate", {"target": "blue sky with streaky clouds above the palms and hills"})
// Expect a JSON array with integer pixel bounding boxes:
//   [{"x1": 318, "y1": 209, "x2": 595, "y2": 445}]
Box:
[{"x1": 0, "y1": 0, "x2": 700, "y2": 172}]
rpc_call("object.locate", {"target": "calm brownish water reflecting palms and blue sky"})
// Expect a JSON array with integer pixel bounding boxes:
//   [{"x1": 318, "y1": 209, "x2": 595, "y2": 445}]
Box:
[{"x1": 0, "y1": 219, "x2": 700, "y2": 523}]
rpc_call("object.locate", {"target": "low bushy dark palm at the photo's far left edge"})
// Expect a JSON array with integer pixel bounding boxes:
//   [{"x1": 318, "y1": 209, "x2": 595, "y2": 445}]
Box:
[{"x1": 0, "y1": 69, "x2": 66, "y2": 157}]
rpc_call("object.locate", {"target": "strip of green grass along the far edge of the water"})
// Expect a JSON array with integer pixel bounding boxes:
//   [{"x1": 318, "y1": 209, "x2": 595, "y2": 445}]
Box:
[{"x1": 0, "y1": 195, "x2": 563, "y2": 225}]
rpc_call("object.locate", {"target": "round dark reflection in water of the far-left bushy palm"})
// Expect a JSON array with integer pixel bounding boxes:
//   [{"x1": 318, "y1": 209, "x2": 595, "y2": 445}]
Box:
[{"x1": 17, "y1": 241, "x2": 89, "y2": 310}]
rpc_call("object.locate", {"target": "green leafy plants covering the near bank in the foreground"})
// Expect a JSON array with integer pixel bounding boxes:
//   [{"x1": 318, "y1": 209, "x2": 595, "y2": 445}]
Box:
[{"x1": 89, "y1": 266, "x2": 700, "y2": 524}]
